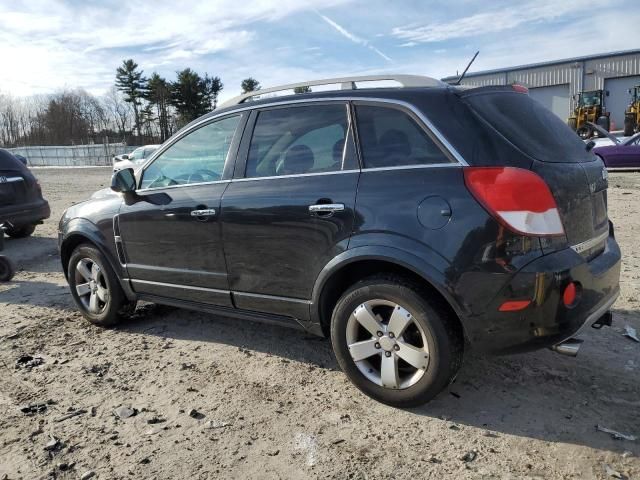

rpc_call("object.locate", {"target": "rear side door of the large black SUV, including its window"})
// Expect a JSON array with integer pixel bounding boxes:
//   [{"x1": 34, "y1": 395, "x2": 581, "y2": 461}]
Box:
[{"x1": 222, "y1": 102, "x2": 359, "y2": 320}]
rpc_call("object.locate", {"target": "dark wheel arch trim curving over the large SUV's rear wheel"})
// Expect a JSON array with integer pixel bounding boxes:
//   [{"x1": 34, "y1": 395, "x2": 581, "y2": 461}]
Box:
[{"x1": 311, "y1": 247, "x2": 466, "y2": 338}]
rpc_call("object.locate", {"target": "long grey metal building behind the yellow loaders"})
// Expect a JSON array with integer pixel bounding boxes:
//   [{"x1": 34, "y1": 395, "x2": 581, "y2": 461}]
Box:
[{"x1": 443, "y1": 50, "x2": 640, "y2": 130}]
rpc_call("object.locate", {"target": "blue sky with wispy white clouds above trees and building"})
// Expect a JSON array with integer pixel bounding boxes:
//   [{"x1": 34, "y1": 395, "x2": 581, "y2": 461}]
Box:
[{"x1": 0, "y1": 0, "x2": 640, "y2": 100}]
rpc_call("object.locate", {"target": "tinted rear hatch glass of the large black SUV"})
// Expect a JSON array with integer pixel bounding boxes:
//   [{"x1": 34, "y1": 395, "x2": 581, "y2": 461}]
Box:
[{"x1": 462, "y1": 91, "x2": 595, "y2": 163}]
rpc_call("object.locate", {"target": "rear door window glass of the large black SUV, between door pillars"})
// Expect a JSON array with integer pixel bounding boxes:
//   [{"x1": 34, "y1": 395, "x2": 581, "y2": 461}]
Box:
[{"x1": 246, "y1": 104, "x2": 355, "y2": 177}]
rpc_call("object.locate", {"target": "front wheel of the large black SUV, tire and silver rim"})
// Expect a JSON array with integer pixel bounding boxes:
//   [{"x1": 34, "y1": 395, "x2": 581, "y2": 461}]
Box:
[{"x1": 67, "y1": 244, "x2": 135, "y2": 327}]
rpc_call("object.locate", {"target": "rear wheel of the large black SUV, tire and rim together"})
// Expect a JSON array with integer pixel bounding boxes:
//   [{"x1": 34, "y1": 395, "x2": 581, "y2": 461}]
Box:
[{"x1": 331, "y1": 276, "x2": 463, "y2": 408}]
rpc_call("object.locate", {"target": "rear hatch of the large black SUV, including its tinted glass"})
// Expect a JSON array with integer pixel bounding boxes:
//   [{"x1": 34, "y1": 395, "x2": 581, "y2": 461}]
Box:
[{"x1": 460, "y1": 87, "x2": 609, "y2": 257}]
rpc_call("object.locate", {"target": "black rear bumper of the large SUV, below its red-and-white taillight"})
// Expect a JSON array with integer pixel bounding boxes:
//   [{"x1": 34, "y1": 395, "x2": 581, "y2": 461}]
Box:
[{"x1": 465, "y1": 236, "x2": 621, "y2": 354}]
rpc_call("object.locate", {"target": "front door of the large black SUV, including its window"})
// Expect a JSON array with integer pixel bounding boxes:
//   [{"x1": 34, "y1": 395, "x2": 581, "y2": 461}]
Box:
[{"x1": 116, "y1": 115, "x2": 241, "y2": 306}]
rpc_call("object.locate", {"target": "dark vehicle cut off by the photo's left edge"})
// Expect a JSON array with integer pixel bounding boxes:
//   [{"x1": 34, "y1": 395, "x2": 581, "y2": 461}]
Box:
[{"x1": 0, "y1": 148, "x2": 51, "y2": 238}]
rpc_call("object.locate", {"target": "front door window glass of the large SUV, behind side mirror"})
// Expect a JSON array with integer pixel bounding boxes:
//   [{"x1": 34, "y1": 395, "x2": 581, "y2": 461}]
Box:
[{"x1": 141, "y1": 115, "x2": 240, "y2": 188}]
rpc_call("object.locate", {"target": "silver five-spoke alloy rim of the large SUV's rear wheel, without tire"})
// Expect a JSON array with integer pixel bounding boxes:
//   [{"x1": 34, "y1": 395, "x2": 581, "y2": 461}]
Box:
[{"x1": 346, "y1": 299, "x2": 429, "y2": 390}]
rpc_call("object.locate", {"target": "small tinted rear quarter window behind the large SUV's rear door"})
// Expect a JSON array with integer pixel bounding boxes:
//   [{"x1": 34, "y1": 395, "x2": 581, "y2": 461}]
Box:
[{"x1": 356, "y1": 105, "x2": 450, "y2": 168}]
